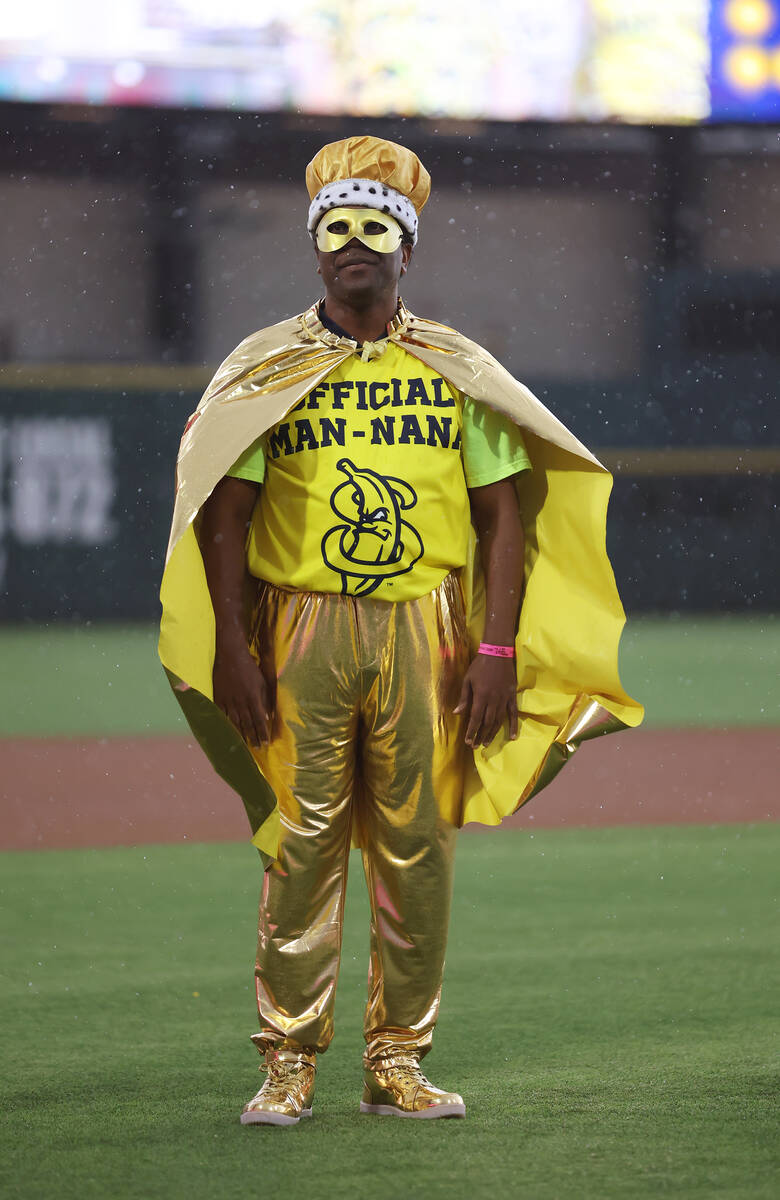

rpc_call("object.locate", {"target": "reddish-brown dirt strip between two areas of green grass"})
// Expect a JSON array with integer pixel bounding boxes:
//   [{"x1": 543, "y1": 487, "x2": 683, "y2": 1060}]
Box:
[{"x1": 0, "y1": 728, "x2": 780, "y2": 850}]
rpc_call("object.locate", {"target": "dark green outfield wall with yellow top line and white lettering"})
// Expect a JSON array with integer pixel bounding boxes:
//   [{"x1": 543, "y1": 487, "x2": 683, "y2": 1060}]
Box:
[{"x1": 0, "y1": 366, "x2": 780, "y2": 622}]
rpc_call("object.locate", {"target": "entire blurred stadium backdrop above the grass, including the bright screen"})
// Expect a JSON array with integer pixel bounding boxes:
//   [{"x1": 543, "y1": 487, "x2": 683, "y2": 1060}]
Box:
[{"x1": 0, "y1": 0, "x2": 780, "y2": 623}]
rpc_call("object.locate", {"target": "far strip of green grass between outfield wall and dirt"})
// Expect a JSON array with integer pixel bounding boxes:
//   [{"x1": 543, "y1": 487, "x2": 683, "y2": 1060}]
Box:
[{"x1": 0, "y1": 616, "x2": 780, "y2": 737}]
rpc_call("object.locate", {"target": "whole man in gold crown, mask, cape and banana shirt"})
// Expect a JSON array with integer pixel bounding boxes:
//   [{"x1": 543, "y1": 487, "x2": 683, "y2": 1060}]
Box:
[{"x1": 160, "y1": 137, "x2": 642, "y2": 1124}]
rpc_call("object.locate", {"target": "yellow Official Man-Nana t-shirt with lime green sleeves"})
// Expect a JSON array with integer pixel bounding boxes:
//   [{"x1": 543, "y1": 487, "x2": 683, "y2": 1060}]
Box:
[{"x1": 224, "y1": 342, "x2": 530, "y2": 600}]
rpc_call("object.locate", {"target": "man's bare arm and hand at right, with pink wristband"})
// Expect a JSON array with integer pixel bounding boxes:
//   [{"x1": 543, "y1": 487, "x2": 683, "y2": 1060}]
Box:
[{"x1": 455, "y1": 478, "x2": 524, "y2": 746}]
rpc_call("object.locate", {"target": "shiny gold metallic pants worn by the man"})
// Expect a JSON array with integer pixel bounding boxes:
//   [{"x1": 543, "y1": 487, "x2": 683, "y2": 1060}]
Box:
[{"x1": 252, "y1": 576, "x2": 468, "y2": 1062}]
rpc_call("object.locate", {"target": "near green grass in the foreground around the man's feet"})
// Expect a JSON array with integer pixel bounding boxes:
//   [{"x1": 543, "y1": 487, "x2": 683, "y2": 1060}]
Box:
[{"x1": 0, "y1": 826, "x2": 780, "y2": 1200}]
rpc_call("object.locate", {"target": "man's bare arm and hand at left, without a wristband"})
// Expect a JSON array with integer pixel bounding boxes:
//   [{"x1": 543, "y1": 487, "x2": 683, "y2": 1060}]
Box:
[{"x1": 200, "y1": 475, "x2": 272, "y2": 745}]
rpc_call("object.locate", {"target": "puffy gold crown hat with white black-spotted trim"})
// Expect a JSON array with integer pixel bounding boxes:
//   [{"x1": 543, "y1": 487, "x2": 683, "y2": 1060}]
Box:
[{"x1": 306, "y1": 137, "x2": 431, "y2": 245}]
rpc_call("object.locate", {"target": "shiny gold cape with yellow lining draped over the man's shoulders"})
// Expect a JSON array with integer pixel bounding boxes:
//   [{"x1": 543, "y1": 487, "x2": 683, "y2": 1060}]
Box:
[{"x1": 160, "y1": 304, "x2": 643, "y2": 860}]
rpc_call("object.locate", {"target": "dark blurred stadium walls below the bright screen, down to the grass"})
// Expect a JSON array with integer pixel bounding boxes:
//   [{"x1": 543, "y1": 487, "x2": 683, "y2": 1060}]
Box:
[{"x1": 0, "y1": 120, "x2": 780, "y2": 620}]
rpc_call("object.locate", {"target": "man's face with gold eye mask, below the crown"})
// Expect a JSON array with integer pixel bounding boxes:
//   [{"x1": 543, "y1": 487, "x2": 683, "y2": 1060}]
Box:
[{"x1": 316, "y1": 205, "x2": 412, "y2": 306}]
